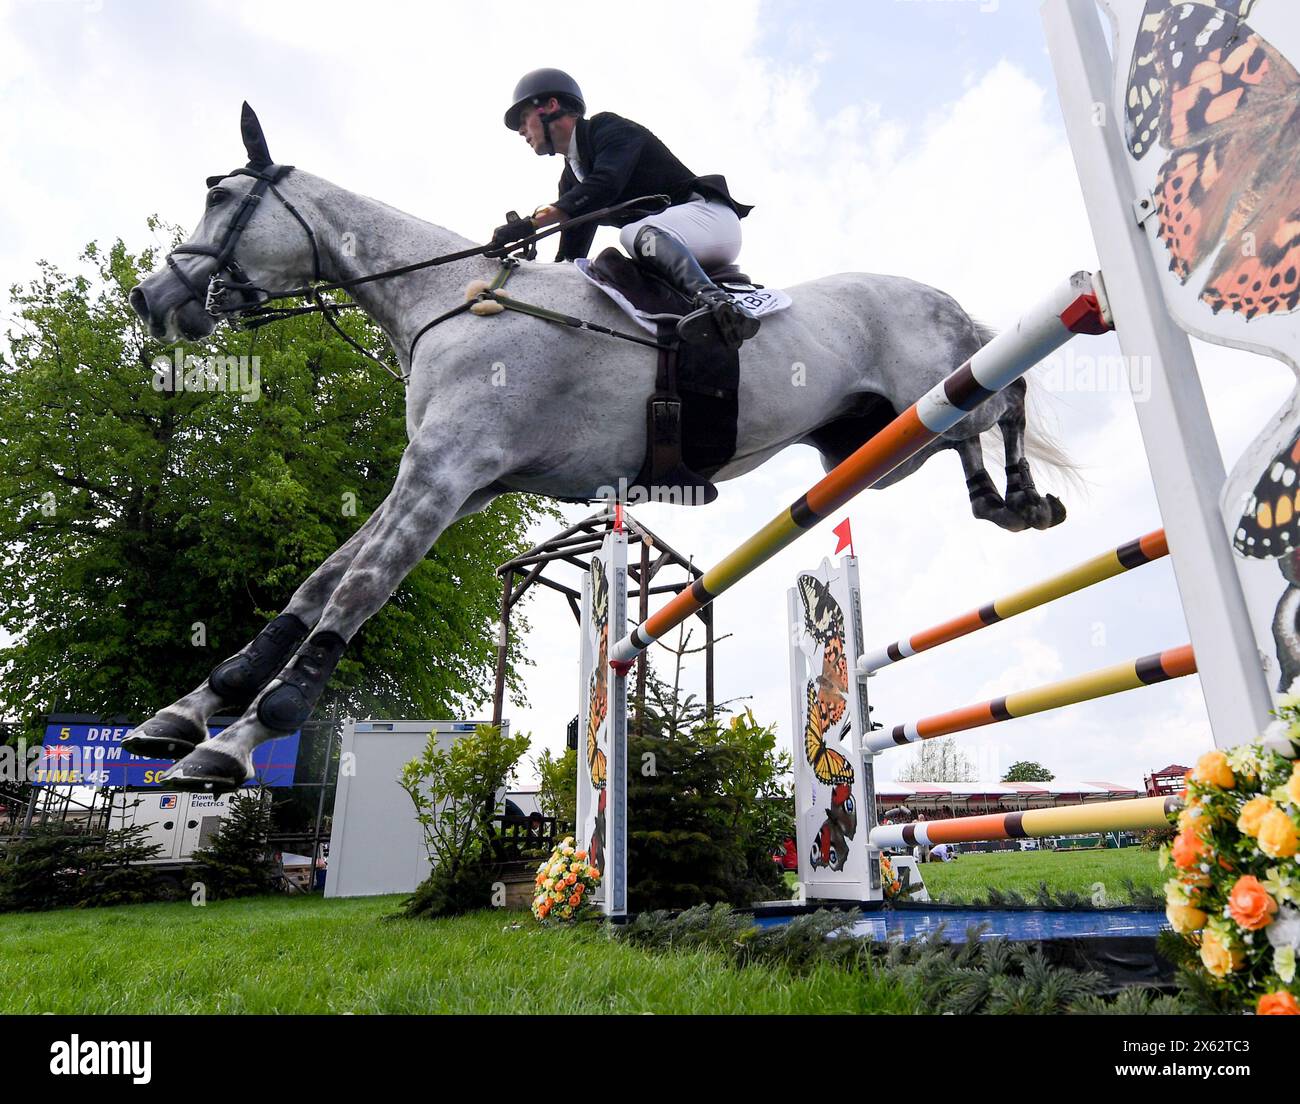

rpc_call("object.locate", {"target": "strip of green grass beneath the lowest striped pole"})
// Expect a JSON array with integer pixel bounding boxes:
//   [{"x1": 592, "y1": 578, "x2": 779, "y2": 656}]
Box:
[{"x1": 920, "y1": 847, "x2": 1165, "y2": 905}]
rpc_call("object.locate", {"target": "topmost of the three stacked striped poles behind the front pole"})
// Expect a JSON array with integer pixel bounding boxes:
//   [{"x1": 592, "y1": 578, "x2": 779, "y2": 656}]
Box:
[{"x1": 858, "y1": 529, "x2": 1169, "y2": 675}]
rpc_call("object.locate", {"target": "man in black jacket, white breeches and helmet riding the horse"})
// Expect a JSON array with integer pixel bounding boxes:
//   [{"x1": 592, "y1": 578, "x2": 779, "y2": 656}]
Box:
[{"x1": 493, "y1": 69, "x2": 758, "y2": 348}]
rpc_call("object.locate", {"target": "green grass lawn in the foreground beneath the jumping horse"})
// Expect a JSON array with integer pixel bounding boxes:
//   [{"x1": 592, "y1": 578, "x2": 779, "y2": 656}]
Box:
[{"x1": 0, "y1": 897, "x2": 920, "y2": 1014}]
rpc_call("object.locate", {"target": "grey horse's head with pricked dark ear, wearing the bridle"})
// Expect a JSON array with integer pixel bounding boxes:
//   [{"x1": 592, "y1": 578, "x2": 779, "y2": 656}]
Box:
[{"x1": 130, "y1": 104, "x2": 320, "y2": 341}]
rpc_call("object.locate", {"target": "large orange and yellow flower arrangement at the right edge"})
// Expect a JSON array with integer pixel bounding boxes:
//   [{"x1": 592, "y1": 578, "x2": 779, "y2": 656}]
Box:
[{"x1": 1161, "y1": 680, "x2": 1300, "y2": 1016}]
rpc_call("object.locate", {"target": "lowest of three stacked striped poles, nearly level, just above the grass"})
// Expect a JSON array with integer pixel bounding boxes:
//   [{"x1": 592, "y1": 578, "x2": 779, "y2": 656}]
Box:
[{"x1": 871, "y1": 797, "x2": 1182, "y2": 848}]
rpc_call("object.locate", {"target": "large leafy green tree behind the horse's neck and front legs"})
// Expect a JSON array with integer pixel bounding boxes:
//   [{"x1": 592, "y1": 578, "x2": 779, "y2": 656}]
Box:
[{"x1": 0, "y1": 220, "x2": 554, "y2": 731}]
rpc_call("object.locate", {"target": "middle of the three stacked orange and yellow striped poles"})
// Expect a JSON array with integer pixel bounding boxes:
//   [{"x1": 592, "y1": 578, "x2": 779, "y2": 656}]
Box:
[{"x1": 862, "y1": 644, "x2": 1196, "y2": 752}]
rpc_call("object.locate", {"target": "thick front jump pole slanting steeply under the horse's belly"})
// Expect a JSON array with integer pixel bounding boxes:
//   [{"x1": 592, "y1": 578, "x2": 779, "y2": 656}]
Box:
[{"x1": 610, "y1": 272, "x2": 1113, "y2": 675}]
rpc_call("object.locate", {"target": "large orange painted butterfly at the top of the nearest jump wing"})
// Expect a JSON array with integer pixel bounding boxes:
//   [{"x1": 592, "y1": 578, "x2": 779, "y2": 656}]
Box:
[{"x1": 1125, "y1": 0, "x2": 1300, "y2": 321}]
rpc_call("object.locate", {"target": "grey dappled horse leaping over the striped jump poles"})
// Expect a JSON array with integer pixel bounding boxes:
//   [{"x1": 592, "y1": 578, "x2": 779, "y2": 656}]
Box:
[{"x1": 129, "y1": 105, "x2": 1067, "y2": 791}]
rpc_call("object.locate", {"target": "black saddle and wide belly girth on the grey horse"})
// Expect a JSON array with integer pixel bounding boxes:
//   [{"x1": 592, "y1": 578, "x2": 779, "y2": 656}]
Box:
[{"x1": 579, "y1": 248, "x2": 754, "y2": 505}]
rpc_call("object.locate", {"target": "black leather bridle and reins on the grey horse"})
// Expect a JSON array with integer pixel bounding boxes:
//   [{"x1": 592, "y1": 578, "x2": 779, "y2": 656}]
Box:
[{"x1": 159, "y1": 163, "x2": 671, "y2": 385}]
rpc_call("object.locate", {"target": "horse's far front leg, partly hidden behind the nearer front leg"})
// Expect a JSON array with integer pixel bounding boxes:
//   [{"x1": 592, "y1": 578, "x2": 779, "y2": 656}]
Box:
[{"x1": 122, "y1": 503, "x2": 385, "y2": 759}]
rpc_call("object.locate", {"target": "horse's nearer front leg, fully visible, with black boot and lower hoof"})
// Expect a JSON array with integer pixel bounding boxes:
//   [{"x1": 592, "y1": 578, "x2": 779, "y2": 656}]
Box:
[{"x1": 163, "y1": 424, "x2": 504, "y2": 792}]
